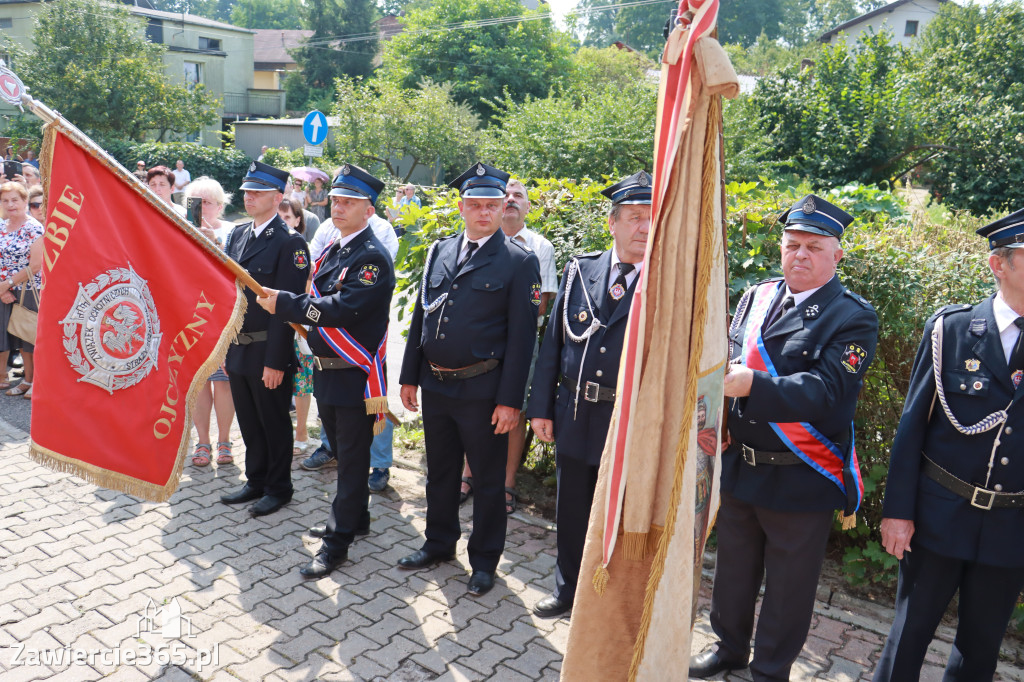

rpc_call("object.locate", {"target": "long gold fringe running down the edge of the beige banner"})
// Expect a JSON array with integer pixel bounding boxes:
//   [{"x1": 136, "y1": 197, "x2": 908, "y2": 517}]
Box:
[{"x1": 629, "y1": 91, "x2": 725, "y2": 682}]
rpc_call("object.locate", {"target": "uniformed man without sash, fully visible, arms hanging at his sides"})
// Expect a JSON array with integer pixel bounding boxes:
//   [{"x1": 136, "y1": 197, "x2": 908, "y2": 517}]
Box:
[{"x1": 398, "y1": 163, "x2": 541, "y2": 596}]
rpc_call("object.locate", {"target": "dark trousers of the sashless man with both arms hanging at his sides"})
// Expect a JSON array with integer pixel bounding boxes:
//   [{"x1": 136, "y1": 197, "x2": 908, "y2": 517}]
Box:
[{"x1": 419, "y1": 390, "x2": 509, "y2": 572}]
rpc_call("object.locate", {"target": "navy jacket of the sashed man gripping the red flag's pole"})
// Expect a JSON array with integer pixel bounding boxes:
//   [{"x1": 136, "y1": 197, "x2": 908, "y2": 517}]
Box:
[{"x1": 278, "y1": 227, "x2": 394, "y2": 407}]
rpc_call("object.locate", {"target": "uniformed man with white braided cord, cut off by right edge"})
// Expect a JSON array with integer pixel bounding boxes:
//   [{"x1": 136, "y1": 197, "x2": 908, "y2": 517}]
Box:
[{"x1": 874, "y1": 210, "x2": 1024, "y2": 682}]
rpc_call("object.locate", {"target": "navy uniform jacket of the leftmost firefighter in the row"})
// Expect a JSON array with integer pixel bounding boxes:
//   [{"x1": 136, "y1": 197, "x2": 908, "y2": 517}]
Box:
[{"x1": 225, "y1": 216, "x2": 310, "y2": 377}]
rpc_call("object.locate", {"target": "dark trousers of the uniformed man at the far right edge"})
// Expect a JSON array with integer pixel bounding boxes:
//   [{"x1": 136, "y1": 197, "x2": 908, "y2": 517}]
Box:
[{"x1": 873, "y1": 539, "x2": 1024, "y2": 682}]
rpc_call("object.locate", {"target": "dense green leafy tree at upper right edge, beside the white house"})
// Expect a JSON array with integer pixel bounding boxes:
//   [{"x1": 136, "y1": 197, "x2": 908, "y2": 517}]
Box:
[{"x1": 903, "y1": 2, "x2": 1024, "y2": 214}]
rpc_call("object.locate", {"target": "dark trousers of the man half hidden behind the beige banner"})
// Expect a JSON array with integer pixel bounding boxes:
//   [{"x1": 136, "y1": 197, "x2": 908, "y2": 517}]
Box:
[{"x1": 555, "y1": 450, "x2": 600, "y2": 604}]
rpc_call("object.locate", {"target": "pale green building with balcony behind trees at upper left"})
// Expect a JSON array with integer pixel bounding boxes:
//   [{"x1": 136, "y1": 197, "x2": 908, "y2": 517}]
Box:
[{"x1": 0, "y1": 0, "x2": 285, "y2": 146}]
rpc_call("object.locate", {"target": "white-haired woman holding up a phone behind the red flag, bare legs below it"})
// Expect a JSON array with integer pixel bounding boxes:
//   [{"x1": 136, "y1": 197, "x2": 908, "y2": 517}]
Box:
[{"x1": 185, "y1": 175, "x2": 234, "y2": 467}]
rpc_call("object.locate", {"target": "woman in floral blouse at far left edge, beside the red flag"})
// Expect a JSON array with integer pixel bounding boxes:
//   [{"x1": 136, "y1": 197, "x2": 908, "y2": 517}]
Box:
[{"x1": 0, "y1": 182, "x2": 43, "y2": 398}]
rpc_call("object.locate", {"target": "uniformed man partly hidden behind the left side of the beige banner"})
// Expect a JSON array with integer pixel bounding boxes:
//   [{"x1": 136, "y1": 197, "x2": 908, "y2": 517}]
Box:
[{"x1": 526, "y1": 171, "x2": 651, "y2": 617}]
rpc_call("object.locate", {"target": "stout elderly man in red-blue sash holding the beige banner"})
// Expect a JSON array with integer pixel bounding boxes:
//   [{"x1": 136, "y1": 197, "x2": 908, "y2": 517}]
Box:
[{"x1": 690, "y1": 195, "x2": 878, "y2": 682}]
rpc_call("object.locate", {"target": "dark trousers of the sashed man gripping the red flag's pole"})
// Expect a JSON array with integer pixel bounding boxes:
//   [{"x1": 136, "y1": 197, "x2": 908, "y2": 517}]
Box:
[{"x1": 319, "y1": 404, "x2": 374, "y2": 555}]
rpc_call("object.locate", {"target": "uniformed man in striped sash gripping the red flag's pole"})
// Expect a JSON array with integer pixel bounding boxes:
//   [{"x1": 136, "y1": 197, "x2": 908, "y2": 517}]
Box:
[{"x1": 259, "y1": 165, "x2": 394, "y2": 578}]
